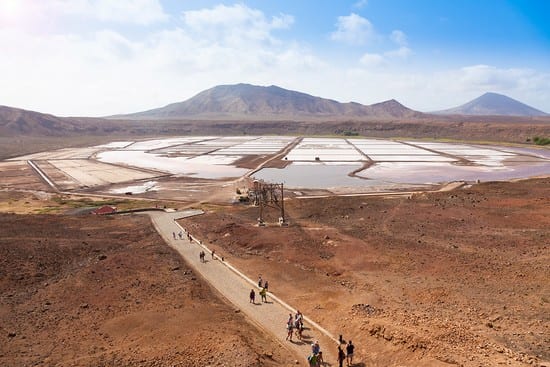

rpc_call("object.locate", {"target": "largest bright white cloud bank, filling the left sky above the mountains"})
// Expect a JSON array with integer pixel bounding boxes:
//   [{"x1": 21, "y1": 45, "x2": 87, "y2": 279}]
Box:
[{"x1": 0, "y1": 5, "x2": 320, "y2": 116}]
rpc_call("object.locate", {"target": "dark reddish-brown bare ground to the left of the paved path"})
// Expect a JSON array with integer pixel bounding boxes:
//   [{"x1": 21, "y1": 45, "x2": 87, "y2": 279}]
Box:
[{"x1": 0, "y1": 214, "x2": 300, "y2": 366}]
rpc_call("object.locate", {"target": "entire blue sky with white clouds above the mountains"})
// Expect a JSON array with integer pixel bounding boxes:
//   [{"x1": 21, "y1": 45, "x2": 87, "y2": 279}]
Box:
[{"x1": 0, "y1": 0, "x2": 550, "y2": 116}]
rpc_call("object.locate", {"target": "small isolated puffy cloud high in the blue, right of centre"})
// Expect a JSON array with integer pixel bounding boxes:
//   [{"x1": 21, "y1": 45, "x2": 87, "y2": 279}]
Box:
[{"x1": 330, "y1": 13, "x2": 375, "y2": 45}]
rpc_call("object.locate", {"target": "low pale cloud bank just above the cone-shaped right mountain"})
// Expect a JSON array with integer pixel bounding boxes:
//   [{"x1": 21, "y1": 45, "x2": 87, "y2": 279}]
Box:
[{"x1": 330, "y1": 64, "x2": 550, "y2": 112}]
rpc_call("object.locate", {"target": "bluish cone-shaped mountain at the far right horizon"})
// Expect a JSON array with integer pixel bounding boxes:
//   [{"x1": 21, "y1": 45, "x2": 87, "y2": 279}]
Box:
[{"x1": 433, "y1": 93, "x2": 548, "y2": 116}]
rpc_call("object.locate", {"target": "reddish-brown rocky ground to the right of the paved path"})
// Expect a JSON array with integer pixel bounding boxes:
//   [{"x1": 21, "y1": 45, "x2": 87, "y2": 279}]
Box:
[{"x1": 183, "y1": 178, "x2": 550, "y2": 366}]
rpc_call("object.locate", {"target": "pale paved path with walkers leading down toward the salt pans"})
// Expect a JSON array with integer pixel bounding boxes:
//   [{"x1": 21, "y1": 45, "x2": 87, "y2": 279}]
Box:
[{"x1": 148, "y1": 210, "x2": 337, "y2": 366}]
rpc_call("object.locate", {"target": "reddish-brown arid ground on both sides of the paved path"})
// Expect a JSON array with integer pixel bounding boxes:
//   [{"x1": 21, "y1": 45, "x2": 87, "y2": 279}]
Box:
[{"x1": 0, "y1": 136, "x2": 550, "y2": 367}]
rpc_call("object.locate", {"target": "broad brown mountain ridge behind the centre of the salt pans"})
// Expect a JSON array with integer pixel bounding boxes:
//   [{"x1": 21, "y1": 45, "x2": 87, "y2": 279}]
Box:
[{"x1": 112, "y1": 84, "x2": 422, "y2": 119}]
